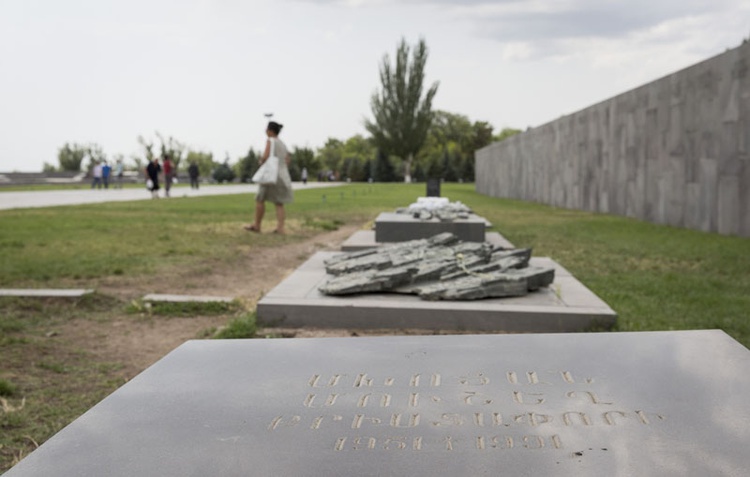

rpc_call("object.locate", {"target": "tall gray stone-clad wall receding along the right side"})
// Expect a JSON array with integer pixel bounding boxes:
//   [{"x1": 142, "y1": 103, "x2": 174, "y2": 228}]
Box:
[{"x1": 476, "y1": 42, "x2": 750, "y2": 237}]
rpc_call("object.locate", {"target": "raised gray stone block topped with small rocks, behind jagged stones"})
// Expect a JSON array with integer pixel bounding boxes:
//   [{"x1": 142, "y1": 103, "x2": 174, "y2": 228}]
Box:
[{"x1": 375, "y1": 212, "x2": 487, "y2": 242}]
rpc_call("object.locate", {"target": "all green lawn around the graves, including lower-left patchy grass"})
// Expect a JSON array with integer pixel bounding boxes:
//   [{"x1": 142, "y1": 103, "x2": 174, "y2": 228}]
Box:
[{"x1": 0, "y1": 184, "x2": 750, "y2": 472}]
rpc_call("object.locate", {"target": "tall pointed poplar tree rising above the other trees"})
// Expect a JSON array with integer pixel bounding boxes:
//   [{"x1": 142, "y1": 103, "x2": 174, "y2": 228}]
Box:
[{"x1": 365, "y1": 38, "x2": 438, "y2": 182}]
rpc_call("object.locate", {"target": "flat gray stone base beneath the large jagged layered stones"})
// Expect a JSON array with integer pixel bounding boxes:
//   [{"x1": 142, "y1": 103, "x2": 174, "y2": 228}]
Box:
[{"x1": 257, "y1": 252, "x2": 617, "y2": 333}]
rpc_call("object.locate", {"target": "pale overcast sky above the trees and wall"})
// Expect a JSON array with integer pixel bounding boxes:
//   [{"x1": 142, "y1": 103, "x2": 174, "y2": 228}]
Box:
[{"x1": 0, "y1": 0, "x2": 750, "y2": 172}]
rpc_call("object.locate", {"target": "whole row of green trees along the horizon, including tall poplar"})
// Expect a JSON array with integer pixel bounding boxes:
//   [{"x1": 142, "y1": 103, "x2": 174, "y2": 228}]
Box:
[{"x1": 44, "y1": 39, "x2": 520, "y2": 182}]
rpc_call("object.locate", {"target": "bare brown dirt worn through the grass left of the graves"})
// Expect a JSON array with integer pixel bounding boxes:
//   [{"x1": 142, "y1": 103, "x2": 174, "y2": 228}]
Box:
[{"x1": 57, "y1": 225, "x2": 370, "y2": 380}]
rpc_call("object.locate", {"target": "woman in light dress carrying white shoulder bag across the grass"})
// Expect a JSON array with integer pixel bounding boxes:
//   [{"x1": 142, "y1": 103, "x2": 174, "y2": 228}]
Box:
[{"x1": 245, "y1": 121, "x2": 294, "y2": 234}]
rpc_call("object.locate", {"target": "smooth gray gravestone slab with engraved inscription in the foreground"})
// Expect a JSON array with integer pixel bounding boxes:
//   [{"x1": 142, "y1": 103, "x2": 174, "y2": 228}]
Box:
[{"x1": 5, "y1": 330, "x2": 750, "y2": 477}]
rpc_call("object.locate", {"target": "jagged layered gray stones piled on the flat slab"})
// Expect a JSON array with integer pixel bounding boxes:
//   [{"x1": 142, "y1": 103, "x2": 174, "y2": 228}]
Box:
[{"x1": 320, "y1": 233, "x2": 555, "y2": 300}]
